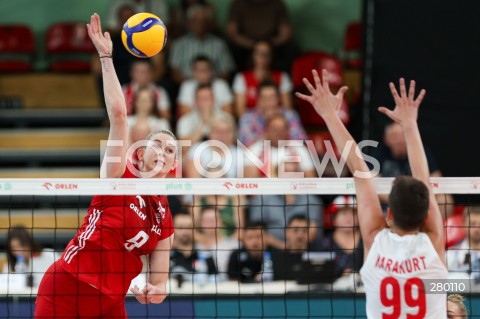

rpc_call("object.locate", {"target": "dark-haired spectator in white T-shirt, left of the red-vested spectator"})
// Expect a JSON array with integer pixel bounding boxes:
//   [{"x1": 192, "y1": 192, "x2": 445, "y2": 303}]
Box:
[{"x1": 177, "y1": 55, "x2": 233, "y2": 116}]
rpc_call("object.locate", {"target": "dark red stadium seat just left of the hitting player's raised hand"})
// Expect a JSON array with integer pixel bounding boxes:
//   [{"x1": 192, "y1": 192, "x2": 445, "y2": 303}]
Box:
[{"x1": 46, "y1": 22, "x2": 95, "y2": 72}]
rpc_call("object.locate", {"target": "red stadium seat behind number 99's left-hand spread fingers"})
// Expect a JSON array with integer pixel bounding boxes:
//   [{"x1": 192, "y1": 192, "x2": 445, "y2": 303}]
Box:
[{"x1": 292, "y1": 52, "x2": 350, "y2": 129}]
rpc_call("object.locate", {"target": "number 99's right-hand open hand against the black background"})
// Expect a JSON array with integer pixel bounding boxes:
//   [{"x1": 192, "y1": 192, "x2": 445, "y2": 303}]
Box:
[{"x1": 378, "y1": 78, "x2": 426, "y2": 126}]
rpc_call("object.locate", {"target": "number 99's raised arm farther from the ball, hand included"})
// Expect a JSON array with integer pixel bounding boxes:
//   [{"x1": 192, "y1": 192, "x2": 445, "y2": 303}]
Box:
[{"x1": 379, "y1": 79, "x2": 445, "y2": 262}]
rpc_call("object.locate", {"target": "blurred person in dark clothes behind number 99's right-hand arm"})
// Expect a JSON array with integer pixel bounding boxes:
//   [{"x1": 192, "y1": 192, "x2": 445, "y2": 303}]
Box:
[{"x1": 373, "y1": 123, "x2": 454, "y2": 218}]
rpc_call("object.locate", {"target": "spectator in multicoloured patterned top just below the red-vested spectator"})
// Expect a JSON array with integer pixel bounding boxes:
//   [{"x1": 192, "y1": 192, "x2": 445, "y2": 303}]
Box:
[{"x1": 239, "y1": 81, "x2": 307, "y2": 146}]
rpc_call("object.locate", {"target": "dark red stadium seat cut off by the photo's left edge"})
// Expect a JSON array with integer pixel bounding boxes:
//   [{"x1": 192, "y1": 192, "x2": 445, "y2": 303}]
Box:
[{"x1": 0, "y1": 24, "x2": 35, "y2": 73}]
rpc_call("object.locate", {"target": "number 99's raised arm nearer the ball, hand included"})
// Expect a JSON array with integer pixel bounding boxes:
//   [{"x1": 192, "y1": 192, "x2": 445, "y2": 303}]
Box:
[{"x1": 296, "y1": 70, "x2": 387, "y2": 256}]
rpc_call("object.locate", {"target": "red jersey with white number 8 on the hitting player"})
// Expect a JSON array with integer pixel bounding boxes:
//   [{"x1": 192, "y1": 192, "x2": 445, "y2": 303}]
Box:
[{"x1": 61, "y1": 169, "x2": 174, "y2": 296}]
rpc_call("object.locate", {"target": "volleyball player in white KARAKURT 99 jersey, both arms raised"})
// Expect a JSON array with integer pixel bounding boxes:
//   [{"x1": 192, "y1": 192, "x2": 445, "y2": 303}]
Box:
[{"x1": 297, "y1": 70, "x2": 447, "y2": 319}]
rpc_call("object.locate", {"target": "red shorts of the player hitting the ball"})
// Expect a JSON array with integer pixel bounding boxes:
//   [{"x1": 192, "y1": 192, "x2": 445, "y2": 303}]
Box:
[{"x1": 35, "y1": 262, "x2": 127, "y2": 319}]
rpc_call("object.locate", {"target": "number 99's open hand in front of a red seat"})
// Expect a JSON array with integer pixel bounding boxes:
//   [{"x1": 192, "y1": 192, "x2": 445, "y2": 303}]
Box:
[{"x1": 295, "y1": 69, "x2": 348, "y2": 119}]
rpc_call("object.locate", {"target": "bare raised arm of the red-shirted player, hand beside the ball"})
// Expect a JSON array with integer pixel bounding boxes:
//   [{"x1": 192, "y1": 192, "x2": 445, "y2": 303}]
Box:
[{"x1": 87, "y1": 13, "x2": 129, "y2": 178}]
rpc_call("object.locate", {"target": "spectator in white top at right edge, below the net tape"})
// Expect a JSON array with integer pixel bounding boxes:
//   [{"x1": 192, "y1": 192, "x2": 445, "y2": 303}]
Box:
[{"x1": 446, "y1": 206, "x2": 480, "y2": 285}]
